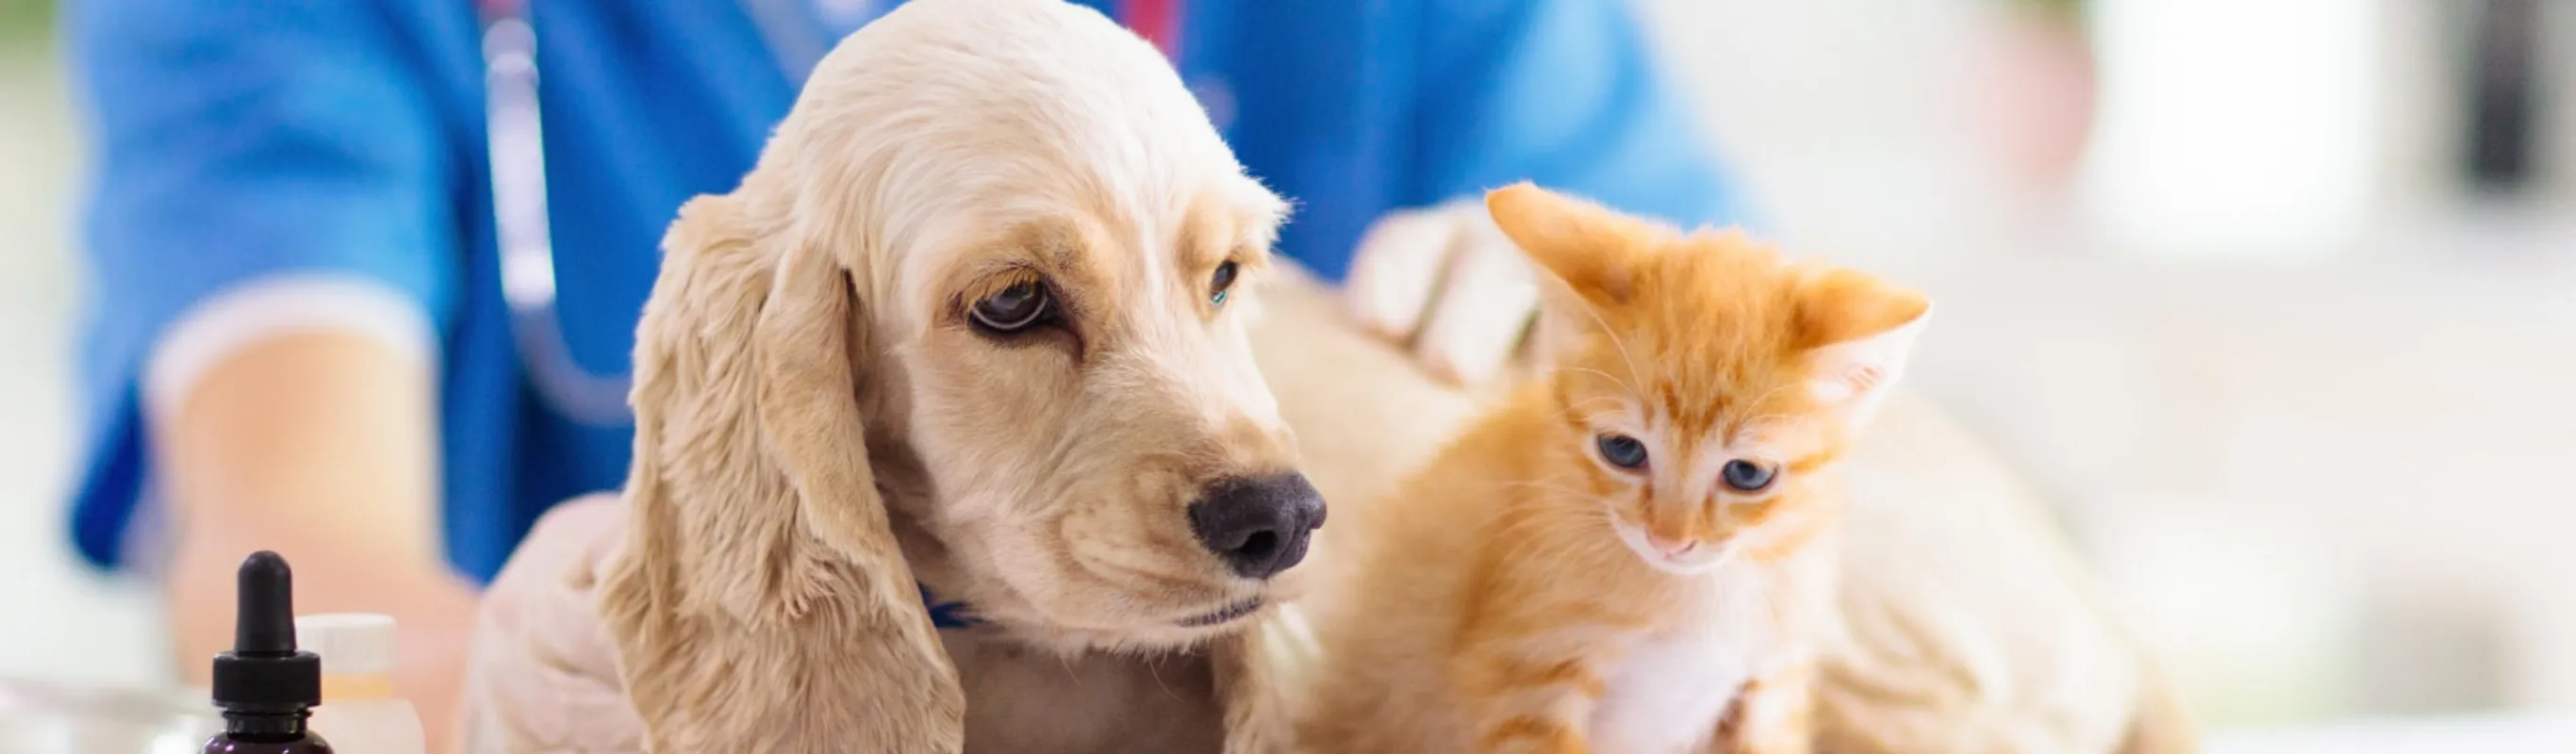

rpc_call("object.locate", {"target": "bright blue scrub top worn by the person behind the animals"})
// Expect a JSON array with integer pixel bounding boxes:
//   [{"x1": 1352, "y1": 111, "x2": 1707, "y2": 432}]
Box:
[{"x1": 67, "y1": 0, "x2": 1739, "y2": 579}]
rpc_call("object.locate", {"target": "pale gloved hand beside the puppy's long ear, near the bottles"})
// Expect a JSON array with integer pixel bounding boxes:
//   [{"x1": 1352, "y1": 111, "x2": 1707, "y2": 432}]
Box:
[{"x1": 458, "y1": 494, "x2": 644, "y2": 751}]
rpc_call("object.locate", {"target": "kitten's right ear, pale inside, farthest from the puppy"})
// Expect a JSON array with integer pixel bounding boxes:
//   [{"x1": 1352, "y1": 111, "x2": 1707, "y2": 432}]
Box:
[{"x1": 1795, "y1": 270, "x2": 1932, "y2": 427}]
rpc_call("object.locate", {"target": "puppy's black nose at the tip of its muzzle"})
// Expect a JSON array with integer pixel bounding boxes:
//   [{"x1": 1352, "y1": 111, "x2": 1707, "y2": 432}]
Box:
[{"x1": 1190, "y1": 471, "x2": 1324, "y2": 579}]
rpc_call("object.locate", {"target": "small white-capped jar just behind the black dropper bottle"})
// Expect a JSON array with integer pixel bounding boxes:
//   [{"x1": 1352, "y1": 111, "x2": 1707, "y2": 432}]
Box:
[{"x1": 296, "y1": 613, "x2": 428, "y2": 754}]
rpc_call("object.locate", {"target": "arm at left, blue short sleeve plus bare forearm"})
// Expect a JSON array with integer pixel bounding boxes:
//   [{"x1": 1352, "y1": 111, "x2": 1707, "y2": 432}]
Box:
[{"x1": 64, "y1": 0, "x2": 471, "y2": 733}]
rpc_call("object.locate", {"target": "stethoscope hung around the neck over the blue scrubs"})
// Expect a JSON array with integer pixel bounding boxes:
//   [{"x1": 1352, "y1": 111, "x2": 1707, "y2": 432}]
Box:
[{"x1": 474, "y1": 0, "x2": 1182, "y2": 427}]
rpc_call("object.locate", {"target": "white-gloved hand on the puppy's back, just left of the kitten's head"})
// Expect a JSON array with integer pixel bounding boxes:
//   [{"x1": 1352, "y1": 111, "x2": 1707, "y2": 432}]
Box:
[{"x1": 1345, "y1": 201, "x2": 1538, "y2": 386}]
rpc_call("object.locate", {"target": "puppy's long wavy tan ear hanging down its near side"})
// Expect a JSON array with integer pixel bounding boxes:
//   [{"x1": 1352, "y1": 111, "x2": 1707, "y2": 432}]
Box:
[{"x1": 601, "y1": 186, "x2": 964, "y2": 751}]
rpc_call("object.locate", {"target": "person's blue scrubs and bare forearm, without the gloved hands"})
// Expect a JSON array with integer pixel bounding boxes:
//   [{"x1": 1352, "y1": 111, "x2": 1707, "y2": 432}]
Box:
[{"x1": 67, "y1": 0, "x2": 1736, "y2": 729}]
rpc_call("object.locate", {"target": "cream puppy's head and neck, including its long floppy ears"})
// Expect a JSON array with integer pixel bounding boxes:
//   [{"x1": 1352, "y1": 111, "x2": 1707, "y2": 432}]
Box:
[{"x1": 598, "y1": 0, "x2": 1324, "y2": 751}]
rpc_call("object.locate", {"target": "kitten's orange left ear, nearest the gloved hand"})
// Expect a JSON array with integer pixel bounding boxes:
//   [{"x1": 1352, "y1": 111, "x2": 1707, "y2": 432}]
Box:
[{"x1": 1484, "y1": 183, "x2": 1667, "y2": 303}]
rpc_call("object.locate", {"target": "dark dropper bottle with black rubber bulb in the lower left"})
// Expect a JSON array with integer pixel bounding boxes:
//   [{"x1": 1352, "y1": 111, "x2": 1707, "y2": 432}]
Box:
[{"x1": 204, "y1": 550, "x2": 332, "y2": 754}]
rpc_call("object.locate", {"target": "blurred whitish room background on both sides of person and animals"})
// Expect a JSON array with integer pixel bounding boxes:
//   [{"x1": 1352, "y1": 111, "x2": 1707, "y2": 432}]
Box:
[{"x1": 0, "y1": 0, "x2": 2576, "y2": 751}]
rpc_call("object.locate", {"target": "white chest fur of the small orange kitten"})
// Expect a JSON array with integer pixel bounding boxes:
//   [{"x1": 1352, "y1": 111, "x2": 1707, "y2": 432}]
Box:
[{"x1": 1590, "y1": 566, "x2": 1783, "y2": 754}]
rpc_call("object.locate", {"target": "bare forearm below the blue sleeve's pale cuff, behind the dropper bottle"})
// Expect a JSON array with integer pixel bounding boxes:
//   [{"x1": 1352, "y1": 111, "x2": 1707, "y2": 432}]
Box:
[{"x1": 152, "y1": 332, "x2": 476, "y2": 751}]
